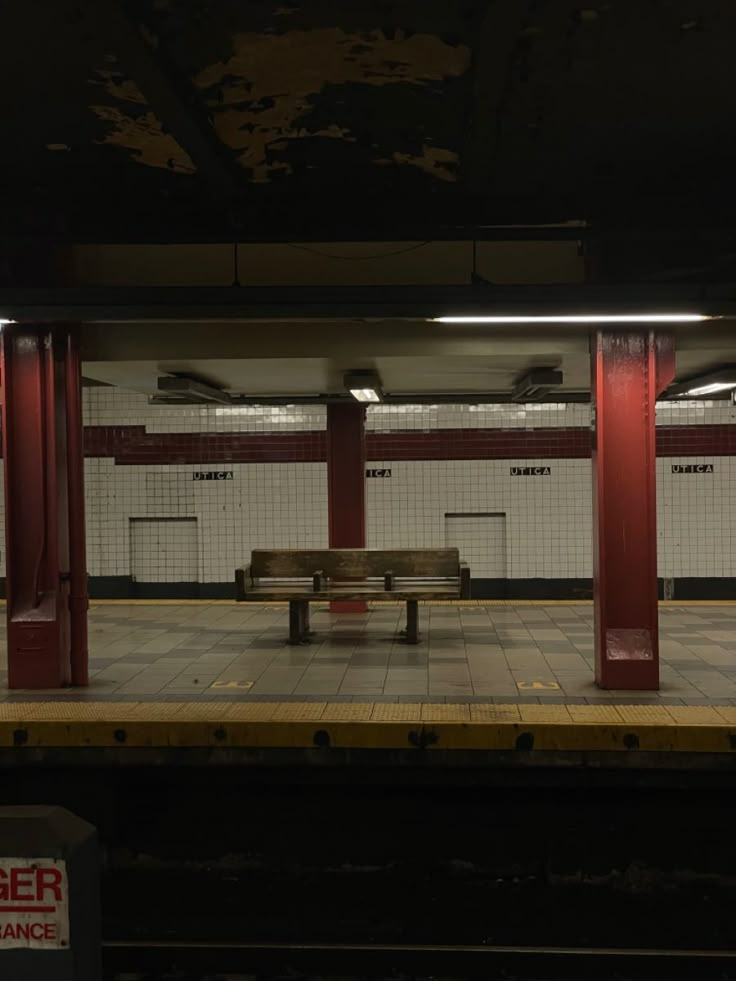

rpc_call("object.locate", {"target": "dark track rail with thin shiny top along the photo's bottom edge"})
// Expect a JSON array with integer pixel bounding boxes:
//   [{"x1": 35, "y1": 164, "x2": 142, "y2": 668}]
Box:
[{"x1": 104, "y1": 941, "x2": 736, "y2": 981}]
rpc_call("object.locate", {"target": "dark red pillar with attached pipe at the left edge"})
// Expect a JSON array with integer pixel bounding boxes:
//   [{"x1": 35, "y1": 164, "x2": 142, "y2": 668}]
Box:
[{"x1": 0, "y1": 325, "x2": 86, "y2": 688}]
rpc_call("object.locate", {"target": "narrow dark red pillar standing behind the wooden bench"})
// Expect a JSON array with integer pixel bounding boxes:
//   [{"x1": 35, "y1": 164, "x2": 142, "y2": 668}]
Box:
[{"x1": 327, "y1": 402, "x2": 367, "y2": 613}]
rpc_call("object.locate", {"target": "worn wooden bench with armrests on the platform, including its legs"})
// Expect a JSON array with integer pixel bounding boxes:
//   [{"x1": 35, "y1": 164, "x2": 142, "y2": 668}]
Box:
[{"x1": 235, "y1": 548, "x2": 470, "y2": 644}]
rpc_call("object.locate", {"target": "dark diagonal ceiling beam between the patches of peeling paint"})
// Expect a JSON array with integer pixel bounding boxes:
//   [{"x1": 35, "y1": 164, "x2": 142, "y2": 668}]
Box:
[{"x1": 86, "y1": 0, "x2": 247, "y2": 202}]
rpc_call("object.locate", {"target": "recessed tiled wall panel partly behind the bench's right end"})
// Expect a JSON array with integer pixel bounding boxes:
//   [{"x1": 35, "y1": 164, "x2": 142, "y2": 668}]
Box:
[{"x1": 445, "y1": 512, "x2": 507, "y2": 599}]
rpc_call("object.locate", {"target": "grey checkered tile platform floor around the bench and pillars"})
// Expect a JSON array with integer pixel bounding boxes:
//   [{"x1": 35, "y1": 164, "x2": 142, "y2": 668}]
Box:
[{"x1": 0, "y1": 603, "x2": 736, "y2": 705}]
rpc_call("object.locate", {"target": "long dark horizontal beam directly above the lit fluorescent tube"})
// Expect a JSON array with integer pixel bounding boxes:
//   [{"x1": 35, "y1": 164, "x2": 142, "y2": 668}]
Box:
[{"x1": 0, "y1": 283, "x2": 736, "y2": 322}]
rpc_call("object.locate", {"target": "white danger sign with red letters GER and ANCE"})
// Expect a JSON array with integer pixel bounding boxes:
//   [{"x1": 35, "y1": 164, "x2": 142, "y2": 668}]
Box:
[{"x1": 0, "y1": 858, "x2": 69, "y2": 950}]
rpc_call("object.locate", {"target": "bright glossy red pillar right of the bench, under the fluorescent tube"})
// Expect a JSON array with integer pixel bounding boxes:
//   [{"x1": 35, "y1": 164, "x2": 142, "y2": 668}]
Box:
[{"x1": 591, "y1": 330, "x2": 675, "y2": 689}]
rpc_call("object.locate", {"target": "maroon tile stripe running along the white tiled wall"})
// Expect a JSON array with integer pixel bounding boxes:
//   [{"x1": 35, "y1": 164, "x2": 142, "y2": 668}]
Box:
[{"x1": 56, "y1": 425, "x2": 736, "y2": 465}]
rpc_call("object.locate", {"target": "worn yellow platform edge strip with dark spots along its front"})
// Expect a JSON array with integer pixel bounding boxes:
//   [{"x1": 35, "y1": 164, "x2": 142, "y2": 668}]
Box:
[{"x1": 0, "y1": 702, "x2": 736, "y2": 754}]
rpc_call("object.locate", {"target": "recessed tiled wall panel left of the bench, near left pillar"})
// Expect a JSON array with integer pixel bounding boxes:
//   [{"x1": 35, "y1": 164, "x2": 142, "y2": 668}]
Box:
[{"x1": 130, "y1": 518, "x2": 199, "y2": 597}]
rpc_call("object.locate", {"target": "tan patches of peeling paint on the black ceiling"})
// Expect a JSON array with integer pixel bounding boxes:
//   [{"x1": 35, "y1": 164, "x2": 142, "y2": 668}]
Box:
[{"x1": 90, "y1": 28, "x2": 471, "y2": 183}]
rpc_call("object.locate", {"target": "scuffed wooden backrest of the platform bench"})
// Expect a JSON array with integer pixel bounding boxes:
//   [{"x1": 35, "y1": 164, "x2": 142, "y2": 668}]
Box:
[{"x1": 250, "y1": 548, "x2": 460, "y2": 579}]
